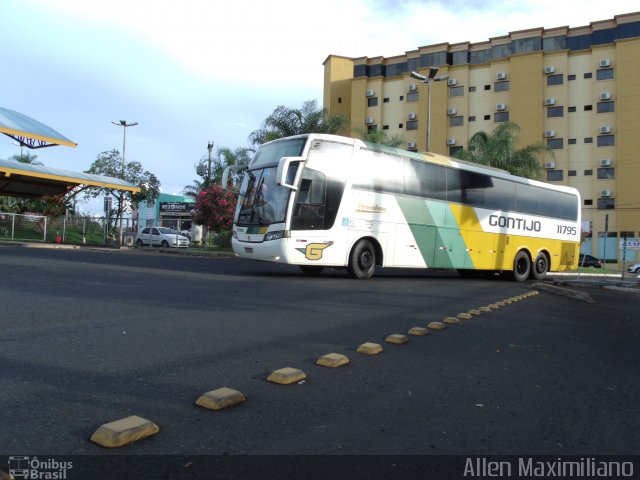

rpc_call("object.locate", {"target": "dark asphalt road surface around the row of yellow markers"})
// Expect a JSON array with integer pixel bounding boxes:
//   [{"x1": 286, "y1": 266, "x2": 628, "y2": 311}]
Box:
[{"x1": 0, "y1": 246, "x2": 640, "y2": 464}]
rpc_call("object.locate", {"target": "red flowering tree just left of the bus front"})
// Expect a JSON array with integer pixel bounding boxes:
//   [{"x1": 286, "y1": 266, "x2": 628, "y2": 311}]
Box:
[{"x1": 195, "y1": 183, "x2": 238, "y2": 232}]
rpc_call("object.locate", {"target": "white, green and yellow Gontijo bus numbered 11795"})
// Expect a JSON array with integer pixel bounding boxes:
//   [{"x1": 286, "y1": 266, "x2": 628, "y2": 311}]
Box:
[{"x1": 228, "y1": 134, "x2": 580, "y2": 281}]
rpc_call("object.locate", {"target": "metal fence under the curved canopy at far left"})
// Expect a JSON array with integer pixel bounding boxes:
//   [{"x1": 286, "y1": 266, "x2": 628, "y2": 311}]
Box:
[{"x1": 0, "y1": 212, "x2": 135, "y2": 246}]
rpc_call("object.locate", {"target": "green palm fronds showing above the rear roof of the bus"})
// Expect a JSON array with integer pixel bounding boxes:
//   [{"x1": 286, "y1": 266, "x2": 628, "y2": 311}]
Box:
[{"x1": 455, "y1": 122, "x2": 555, "y2": 180}]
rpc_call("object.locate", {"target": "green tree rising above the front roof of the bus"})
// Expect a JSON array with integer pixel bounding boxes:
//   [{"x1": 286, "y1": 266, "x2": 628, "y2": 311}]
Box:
[{"x1": 249, "y1": 100, "x2": 349, "y2": 146}]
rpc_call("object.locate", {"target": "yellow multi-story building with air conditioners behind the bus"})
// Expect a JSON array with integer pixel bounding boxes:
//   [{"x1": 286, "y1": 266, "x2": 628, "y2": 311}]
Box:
[{"x1": 324, "y1": 12, "x2": 640, "y2": 263}]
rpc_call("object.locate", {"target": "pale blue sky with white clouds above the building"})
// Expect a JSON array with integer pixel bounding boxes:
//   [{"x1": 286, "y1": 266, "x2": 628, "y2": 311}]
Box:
[{"x1": 0, "y1": 0, "x2": 640, "y2": 214}]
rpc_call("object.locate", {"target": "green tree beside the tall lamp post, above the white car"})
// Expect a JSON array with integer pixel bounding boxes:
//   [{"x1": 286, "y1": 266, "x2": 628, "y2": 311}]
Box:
[{"x1": 85, "y1": 149, "x2": 160, "y2": 228}]
